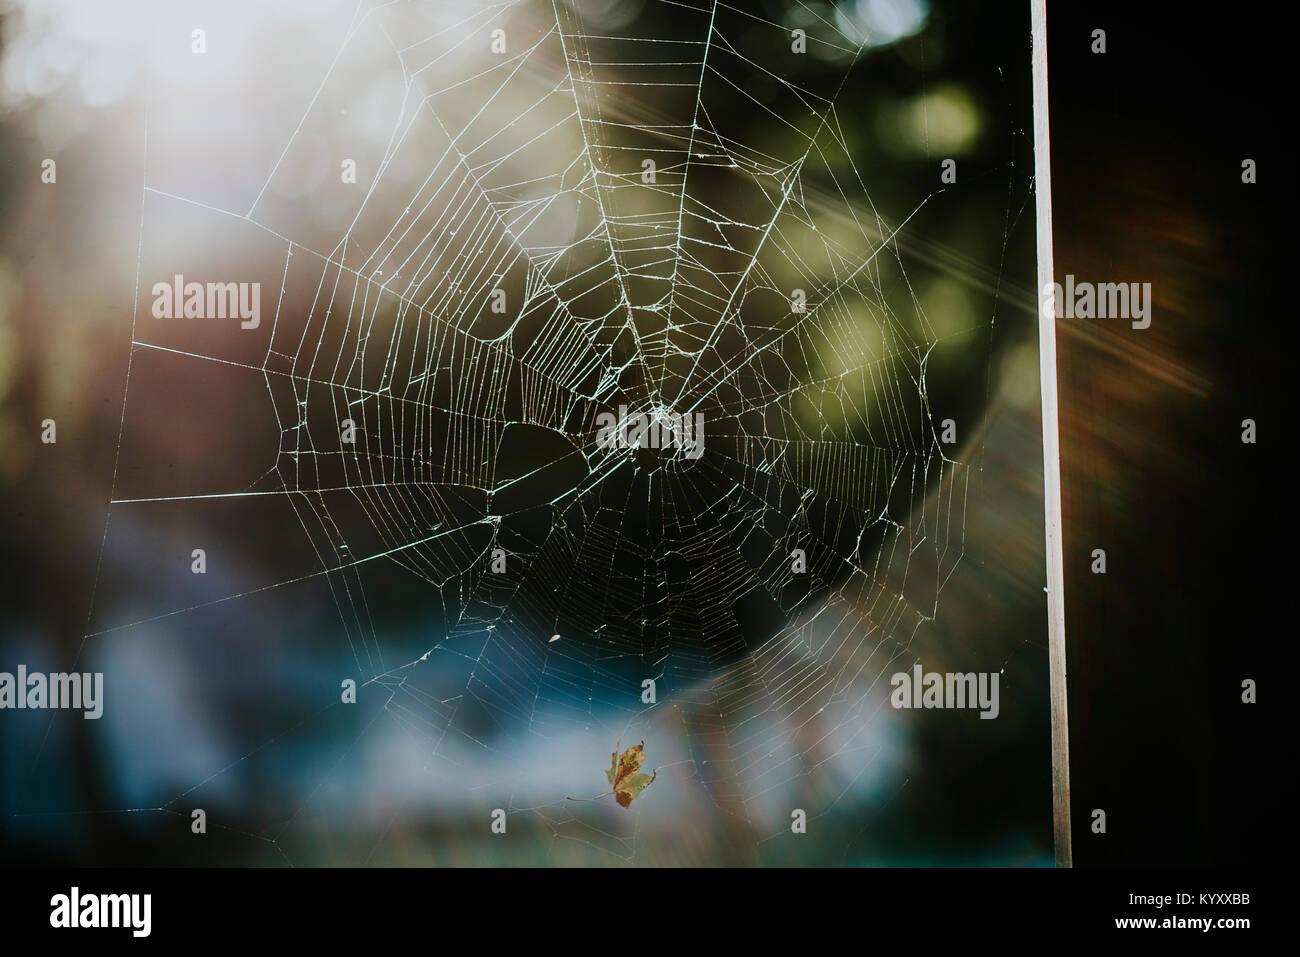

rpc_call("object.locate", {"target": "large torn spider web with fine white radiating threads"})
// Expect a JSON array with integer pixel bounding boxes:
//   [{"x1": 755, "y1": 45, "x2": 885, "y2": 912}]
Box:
[{"x1": 83, "y1": 0, "x2": 1024, "y2": 861}]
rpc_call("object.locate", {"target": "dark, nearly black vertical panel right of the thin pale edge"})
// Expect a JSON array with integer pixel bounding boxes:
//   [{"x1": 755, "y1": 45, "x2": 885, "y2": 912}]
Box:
[{"x1": 1048, "y1": 3, "x2": 1296, "y2": 866}]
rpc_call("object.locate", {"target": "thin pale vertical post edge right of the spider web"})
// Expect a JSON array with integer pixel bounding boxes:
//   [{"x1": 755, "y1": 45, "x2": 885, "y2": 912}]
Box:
[{"x1": 1030, "y1": 0, "x2": 1074, "y2": 867}]
